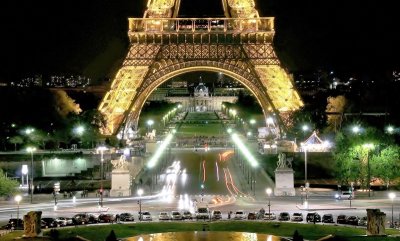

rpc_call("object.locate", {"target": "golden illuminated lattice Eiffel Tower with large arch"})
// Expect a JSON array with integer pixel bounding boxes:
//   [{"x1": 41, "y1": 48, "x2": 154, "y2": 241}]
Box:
[{"x1": 98, "y1": 0, "x2": 303, "y2": 135}]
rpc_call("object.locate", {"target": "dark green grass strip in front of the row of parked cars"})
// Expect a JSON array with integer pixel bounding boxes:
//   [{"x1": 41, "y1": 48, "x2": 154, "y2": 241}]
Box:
[{"x1": 1, "y1": 221, "x2": 400, "y2": 241}]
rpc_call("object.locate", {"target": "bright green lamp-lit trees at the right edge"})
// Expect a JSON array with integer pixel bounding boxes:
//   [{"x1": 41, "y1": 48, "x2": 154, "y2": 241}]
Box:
[{"x1": 334, "y1": 127, "x2": 400, "y2": 188}]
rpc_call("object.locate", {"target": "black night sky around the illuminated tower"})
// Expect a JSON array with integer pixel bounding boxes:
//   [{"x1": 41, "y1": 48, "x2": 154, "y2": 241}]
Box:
[{"x1": 0, "y1": 0, "x2": 400, "y2": 81}]
